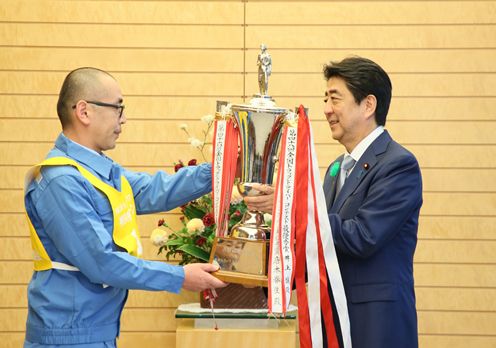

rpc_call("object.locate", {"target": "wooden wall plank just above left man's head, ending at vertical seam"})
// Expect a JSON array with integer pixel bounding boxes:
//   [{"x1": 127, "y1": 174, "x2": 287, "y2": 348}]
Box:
[{"x1": 0, "y1": 47, "x2": 243, "y2": 73}]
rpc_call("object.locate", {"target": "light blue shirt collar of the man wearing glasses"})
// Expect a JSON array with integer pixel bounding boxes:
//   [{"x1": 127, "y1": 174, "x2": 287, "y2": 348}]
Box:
[{"x1": 55, "y1": 133, "x2": 112, "y2": 179}]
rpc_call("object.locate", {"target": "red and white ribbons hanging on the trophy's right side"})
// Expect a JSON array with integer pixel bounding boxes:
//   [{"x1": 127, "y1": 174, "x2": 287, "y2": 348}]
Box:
[{"x1": 269, "y1": 106, "x2": 351, "y2": 348}]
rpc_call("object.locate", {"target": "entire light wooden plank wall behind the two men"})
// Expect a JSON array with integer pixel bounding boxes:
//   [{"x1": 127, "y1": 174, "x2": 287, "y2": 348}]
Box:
[{"x1": 0, "y1": 0, "x2": 496, "y2": 348}]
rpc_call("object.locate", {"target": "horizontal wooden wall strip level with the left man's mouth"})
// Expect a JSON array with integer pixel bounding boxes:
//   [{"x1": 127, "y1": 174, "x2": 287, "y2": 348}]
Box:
[{"x1": 0, "y1": 117, "x2": 496, "y2": 145}]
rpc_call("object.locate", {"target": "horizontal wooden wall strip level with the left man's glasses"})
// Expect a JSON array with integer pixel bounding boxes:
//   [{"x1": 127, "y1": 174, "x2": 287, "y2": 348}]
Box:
[{"x1": 0, "y1": 94, "x2": 496, "y2": 121}]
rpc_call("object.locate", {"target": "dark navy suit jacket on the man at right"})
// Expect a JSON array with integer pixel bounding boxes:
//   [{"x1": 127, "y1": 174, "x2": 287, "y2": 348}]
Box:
[{"x1": 324, "y1": 131, "x2": 422, "y2": 348}]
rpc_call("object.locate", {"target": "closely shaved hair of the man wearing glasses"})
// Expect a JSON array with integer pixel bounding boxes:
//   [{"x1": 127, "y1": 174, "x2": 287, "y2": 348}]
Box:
[{"x1": 57, "y1": 67, "x2": 113, "y2": 128}]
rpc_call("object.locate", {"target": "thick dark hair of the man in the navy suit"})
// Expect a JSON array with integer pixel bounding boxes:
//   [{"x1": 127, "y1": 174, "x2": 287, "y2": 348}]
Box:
[{"x1": 324, "y1": 56, "x2": 392, "y2": 126}]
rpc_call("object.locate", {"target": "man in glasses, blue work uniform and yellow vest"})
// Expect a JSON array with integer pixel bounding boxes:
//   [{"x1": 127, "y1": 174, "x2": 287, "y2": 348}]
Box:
[{"x1": 24, "y1": 68, "x2": 226, "y2": 348}]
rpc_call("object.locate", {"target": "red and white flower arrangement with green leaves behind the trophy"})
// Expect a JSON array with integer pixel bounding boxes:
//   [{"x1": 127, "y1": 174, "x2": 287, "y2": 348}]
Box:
[{"x1": 150, "y1": 115, "x2": 247, "y2": 265}]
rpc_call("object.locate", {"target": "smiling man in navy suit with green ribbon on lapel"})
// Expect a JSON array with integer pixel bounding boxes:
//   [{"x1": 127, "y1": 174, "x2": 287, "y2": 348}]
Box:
[{"x1": 324, "y1": 57, "x2": 422, "y2": 348}]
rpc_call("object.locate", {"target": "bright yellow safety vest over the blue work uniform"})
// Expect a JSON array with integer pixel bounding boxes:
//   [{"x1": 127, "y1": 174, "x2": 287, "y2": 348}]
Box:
[{"x1": 26, "y1": 157, "x2": 143, "y2": 271}]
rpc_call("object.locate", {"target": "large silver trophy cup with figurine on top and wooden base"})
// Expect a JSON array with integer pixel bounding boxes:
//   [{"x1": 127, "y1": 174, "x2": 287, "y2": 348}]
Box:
[{"x1": 210, "y1": 44, "x2": 289, "y2": 286}]
